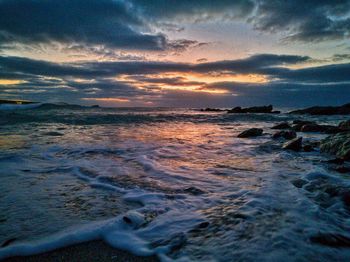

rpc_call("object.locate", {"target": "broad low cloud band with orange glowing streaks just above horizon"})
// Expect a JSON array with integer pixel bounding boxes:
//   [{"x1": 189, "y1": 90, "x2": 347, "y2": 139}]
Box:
[{"x1": 0, "y1": 54, "x2": 350, "y2": 106}]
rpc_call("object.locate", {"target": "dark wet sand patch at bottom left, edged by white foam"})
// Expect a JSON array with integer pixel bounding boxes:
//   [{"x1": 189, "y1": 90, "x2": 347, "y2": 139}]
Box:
[{"x1": 3, "y1": 240, "x2": 159, "y2": 262}]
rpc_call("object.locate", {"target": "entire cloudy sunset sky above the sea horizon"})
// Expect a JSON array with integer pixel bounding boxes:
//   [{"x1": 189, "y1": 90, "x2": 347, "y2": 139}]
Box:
[{"x1": 0, "y1": 0, "x2": 350, "y2": 107}]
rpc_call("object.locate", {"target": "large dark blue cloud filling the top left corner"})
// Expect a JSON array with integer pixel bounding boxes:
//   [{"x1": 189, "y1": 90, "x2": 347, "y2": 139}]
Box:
[{"x1": 0, "y1": 0, "x2": 190, "y2": 50}]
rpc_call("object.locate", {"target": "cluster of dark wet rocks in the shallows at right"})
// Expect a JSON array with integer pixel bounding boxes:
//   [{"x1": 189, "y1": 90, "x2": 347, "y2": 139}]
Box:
[{"x1": 237, "y1": 120, "x2": 350, "y2": 160}]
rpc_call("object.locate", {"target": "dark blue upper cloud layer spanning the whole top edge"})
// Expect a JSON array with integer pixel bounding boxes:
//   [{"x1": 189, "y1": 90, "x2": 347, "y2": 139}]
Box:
[{"x1": 0, "y1": 0, "x2": 350, "y2": 50}]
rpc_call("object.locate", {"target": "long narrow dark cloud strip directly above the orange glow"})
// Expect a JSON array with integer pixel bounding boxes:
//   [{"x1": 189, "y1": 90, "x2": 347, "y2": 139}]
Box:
[{"x1": 0, "y1": 54, "x2": 310, "y2": 78}]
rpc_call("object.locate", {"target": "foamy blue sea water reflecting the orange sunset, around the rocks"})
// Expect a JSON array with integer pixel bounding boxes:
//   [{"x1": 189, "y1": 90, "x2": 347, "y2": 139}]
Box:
[{"x1": 0, "y1": 105, "x2": 350, "y2": 261}]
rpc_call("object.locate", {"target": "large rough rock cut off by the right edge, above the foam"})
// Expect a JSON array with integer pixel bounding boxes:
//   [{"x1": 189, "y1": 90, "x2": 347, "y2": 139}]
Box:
[{"x1": 320, "y1": 132, "x2": 350, "y2": 160}]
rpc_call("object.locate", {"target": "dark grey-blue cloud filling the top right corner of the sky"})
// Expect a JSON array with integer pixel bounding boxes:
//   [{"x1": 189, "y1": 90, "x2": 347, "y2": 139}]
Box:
[{"x1": 250, "y1": 0, "x2": 350, "y2": 42}]
